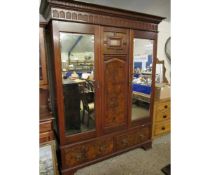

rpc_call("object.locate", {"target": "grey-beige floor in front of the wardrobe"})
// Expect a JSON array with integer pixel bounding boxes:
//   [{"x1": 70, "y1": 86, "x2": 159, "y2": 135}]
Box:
[{"x1": 75, "y1": 134, "x2": 170, "y2": 175}]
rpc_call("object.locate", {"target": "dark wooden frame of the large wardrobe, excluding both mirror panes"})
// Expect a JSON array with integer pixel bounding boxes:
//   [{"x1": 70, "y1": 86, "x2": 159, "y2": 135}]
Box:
[{"x1": 40, "y1": 0, "x2": 164, "y2": 175}]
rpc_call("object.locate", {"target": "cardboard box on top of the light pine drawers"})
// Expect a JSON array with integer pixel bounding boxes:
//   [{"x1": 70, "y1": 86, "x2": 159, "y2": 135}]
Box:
[{"x1": 155, "y1": 83, "x2": 171, "y2": 100}]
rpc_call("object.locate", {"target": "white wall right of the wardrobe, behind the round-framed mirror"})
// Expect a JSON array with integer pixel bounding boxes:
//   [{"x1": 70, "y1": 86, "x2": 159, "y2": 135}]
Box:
[{"x1": 157, "y1": 21, "x2": 171, "y2": 82}]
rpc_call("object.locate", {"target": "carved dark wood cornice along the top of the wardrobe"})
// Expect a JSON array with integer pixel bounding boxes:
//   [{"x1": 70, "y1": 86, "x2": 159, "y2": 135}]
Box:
[{"x1": 40, "y1": 0, "x2": 164, "y2": 31}]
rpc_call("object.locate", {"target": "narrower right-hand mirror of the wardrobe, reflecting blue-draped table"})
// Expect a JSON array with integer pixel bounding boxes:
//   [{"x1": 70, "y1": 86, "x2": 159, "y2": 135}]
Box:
[{"x1": 131, "y1": 38, "x2": 153, "y2": 120}]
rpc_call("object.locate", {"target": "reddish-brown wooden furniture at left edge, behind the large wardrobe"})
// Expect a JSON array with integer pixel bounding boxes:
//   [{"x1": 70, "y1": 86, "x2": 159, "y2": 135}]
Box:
[{"x1": 39, "y1": 22, "x2": 54, "y2": 144}]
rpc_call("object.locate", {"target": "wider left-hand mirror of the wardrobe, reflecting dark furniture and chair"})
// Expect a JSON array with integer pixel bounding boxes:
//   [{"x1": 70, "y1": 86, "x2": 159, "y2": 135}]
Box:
[{"x1": 60, "y1": 32, "x2": 95, "y2": 135}]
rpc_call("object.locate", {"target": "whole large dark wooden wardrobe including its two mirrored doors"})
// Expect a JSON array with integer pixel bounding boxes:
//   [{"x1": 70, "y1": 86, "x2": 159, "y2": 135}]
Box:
[{"x1": 40, "y1": 0, "x2": 164, "y2": 175}]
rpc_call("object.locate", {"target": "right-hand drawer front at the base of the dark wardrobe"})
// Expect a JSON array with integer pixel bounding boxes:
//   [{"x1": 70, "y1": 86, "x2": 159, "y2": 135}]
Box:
[{"x1": 116, "y1": 127, "x2": 150, "y2": 150}]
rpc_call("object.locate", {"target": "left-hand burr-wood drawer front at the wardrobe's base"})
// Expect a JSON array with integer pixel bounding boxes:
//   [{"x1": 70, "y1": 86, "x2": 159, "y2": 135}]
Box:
[{"x1": 63, "y1": 138, "x2": 113, "y2": 168}]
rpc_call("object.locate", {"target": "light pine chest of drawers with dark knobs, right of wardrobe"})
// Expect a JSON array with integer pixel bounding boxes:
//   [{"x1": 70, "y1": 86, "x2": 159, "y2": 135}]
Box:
[{"x1": 152, "y1": 98, "x2": 171, "y2": 138}]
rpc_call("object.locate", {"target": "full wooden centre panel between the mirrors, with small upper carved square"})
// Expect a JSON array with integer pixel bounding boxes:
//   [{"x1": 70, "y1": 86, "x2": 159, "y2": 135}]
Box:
[{"x1": 102, "y1": 27, "x2": 129, "y2": 133}]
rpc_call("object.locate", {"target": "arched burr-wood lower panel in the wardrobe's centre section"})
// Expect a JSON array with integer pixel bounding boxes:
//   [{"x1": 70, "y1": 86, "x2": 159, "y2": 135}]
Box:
[{"x1": 104, "y1": 57, "x2": 127, "y2": 127}]
